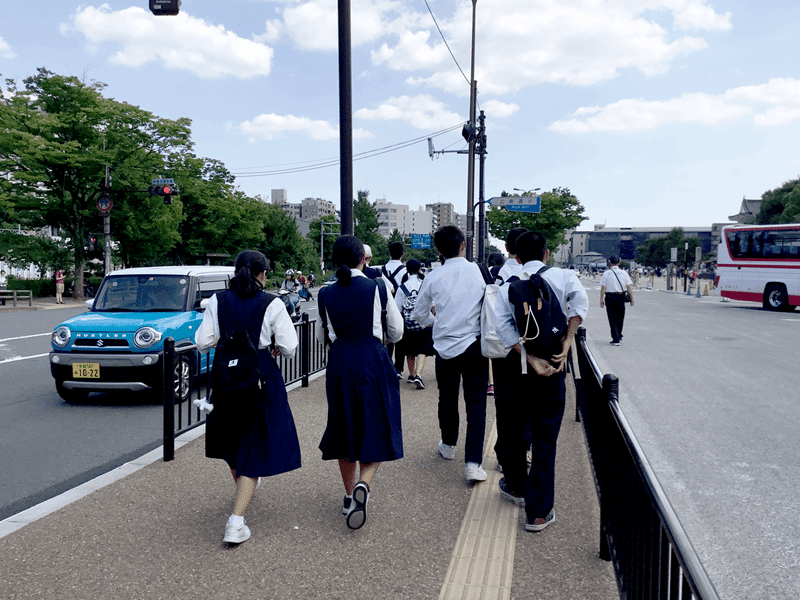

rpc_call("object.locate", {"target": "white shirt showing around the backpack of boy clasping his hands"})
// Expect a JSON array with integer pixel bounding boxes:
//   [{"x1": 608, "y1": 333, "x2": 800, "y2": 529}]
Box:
[{"x1": 494, "y1": 260, "x2": 589, "y2": 349}]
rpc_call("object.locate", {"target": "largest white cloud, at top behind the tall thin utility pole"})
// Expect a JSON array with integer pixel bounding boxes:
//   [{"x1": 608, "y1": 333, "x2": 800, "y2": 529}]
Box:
[{"x1": 372, "y1": 0, "x2": 731, "y2": 95}]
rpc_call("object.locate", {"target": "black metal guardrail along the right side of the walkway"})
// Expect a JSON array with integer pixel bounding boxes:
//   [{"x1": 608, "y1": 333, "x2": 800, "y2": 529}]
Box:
[{"x1": 573, "y1": 327, "x2": 719, "y2": 600}]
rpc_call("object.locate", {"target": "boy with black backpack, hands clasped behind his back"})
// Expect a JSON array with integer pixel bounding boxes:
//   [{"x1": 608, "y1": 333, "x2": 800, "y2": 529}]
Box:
[{"x1": 495, "y1": 232, "x2": 589, "y2": 531}]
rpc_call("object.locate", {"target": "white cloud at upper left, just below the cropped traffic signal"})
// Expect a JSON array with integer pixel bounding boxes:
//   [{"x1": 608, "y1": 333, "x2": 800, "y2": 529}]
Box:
[{"x1": 66, "y1": 5, "x2": 273, "y2": 79}]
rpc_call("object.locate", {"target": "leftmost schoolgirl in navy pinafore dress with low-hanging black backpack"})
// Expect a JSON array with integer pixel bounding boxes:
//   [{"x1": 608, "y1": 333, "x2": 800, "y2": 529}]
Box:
[{"x1": 195, "y1": 250, "x2": 300, "y2": 544}]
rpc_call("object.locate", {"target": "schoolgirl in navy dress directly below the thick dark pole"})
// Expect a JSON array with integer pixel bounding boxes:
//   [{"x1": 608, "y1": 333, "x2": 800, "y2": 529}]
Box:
[{"x1": 318, "y1": 235, "x2": 403, "y2": 529}]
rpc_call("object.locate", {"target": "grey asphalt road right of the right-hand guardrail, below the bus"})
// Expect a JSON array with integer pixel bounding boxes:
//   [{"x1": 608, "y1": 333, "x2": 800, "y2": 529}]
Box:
[{"x1": 585, "y1": 281, "x2": 800, "y2": 600}]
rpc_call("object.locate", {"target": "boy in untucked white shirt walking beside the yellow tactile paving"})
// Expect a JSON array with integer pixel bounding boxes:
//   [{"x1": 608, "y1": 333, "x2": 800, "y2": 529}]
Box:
[{"x1": 413, "y1": 225, "x2": 489, "y2": 482}]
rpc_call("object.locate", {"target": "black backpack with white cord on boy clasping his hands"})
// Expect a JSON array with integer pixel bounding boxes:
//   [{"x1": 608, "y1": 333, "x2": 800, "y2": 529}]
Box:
[{"x1": 508, "y1": 267, "x2": 567, "y2": 360}]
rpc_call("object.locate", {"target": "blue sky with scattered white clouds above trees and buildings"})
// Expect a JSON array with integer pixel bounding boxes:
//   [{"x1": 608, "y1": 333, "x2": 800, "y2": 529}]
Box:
[{"x1": 0, "y1": 0, "x2": 800, "y2": 229}]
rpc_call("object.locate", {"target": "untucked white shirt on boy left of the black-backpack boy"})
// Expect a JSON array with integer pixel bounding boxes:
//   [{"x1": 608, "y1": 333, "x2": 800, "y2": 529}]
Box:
[{"x1": 413, "y1": 257, "x2": 486, "y2": 360}]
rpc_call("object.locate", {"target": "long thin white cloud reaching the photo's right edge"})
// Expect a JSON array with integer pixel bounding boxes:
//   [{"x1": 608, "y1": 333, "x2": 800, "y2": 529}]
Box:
[{"x1": 549, "y1": 78, "x2": 800, "y2": 133}]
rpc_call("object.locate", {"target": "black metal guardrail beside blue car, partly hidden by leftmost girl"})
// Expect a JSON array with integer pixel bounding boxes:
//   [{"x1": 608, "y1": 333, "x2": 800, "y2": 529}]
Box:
[{"x1": 163, "y1": 313, "x2": 328, "y2": 461}]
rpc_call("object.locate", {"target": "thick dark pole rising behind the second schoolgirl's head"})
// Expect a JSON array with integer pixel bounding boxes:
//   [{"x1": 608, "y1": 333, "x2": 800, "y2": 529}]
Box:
[{"x1": 339, "y1": 0, "x2": 354, "y2": 235}]
